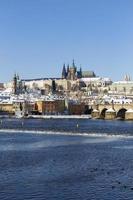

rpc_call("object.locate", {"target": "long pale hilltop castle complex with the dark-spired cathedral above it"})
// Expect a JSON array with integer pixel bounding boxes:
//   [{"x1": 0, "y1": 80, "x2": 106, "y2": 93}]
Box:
[{"x1": 5, "y1": 60, "x2": 111, "y2": 94}]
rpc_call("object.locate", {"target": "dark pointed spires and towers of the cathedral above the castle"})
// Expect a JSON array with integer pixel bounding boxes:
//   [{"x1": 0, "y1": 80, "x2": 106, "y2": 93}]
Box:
[{"x1": 62, "y1": 60, "x2": 82, "y2": 81}]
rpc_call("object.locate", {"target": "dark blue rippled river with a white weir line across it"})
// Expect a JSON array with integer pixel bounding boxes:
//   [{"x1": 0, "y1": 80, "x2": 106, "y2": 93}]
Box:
[{"x1": 0, "y1": 119, "x2": 133, "y2": 200}]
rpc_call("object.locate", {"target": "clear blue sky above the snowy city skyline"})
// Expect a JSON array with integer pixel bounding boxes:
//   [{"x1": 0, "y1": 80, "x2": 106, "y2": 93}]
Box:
[{"x1": 0, "y1": 0, "x2": 133, "y2": 82}]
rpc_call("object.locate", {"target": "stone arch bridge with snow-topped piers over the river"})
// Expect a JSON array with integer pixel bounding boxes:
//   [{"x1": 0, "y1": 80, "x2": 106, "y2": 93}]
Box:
[{"x1": 92, "y1": 103, "x2": 133, "y2": 119}]
